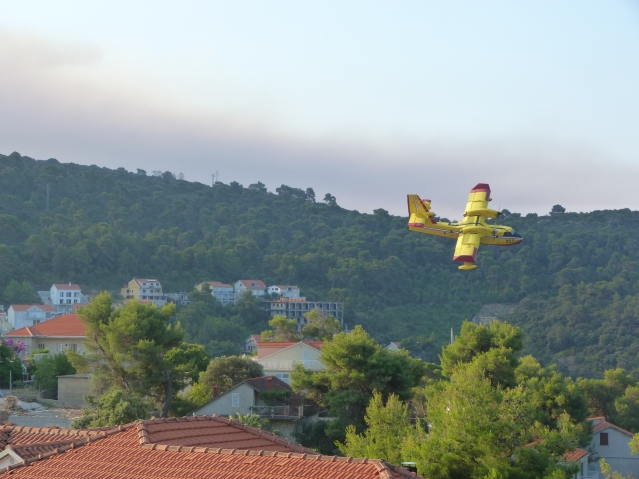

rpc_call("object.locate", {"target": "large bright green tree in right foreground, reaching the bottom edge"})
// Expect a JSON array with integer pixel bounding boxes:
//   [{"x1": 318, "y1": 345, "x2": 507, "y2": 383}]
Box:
[{"x1": 402, "y1": 361, "x2": 578, "y2": 479}]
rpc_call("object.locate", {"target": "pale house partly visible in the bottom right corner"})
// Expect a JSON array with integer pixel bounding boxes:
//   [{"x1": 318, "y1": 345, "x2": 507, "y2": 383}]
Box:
[{"x1": 589, "y1": 417, "x2": 639, "y2": 477}]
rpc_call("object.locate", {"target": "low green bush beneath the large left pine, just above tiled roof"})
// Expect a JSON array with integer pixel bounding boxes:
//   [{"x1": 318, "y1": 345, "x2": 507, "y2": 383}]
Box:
[{"x1": 71, "y1": 390, "x2": 151, "y2": 429}]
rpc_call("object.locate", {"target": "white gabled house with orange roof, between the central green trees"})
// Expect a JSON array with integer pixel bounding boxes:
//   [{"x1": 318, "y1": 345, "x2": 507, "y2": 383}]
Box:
[{"x1": 255, "y1": 340, "x2": 325, "y2": 384}]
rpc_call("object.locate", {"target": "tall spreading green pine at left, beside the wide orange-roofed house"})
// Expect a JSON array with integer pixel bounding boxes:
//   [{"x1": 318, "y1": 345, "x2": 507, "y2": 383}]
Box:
[{"x1": 71, "y1": 293, "x2": 192, "y2": 417}]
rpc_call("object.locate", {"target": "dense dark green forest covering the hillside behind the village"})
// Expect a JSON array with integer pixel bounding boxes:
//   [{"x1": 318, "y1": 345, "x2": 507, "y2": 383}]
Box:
[{"x1": 0, "y1": 153, "x2": 639, "y2": 377}]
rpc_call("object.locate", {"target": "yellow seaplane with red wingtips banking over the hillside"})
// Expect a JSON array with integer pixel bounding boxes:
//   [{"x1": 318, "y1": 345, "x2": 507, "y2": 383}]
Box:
[{"x1": 408, "y1": 183, "x2": 524, "y2": 270}]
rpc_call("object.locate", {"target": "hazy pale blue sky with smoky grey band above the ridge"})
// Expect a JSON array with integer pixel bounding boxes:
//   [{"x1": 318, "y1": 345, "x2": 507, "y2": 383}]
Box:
[{"x1": 0, "y1": 0, "x2": 639, "y2": 218}]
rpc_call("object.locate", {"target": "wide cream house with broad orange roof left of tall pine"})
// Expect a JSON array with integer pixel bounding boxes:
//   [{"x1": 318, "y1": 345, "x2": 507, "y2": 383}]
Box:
[{"x1": 3, "y1": 314, "x2": 86, "y2": 357}]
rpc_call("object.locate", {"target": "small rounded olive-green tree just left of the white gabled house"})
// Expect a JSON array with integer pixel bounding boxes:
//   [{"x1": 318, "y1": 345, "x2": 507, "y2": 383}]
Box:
[{"x1": 198, "y1": 356, "x2": 264, "y2": 399}]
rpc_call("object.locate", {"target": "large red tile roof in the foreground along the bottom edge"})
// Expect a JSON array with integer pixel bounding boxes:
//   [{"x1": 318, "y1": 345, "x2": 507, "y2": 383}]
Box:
[{"x1": 0, "y1": 416, "x2": 419, "y2": 479}]
